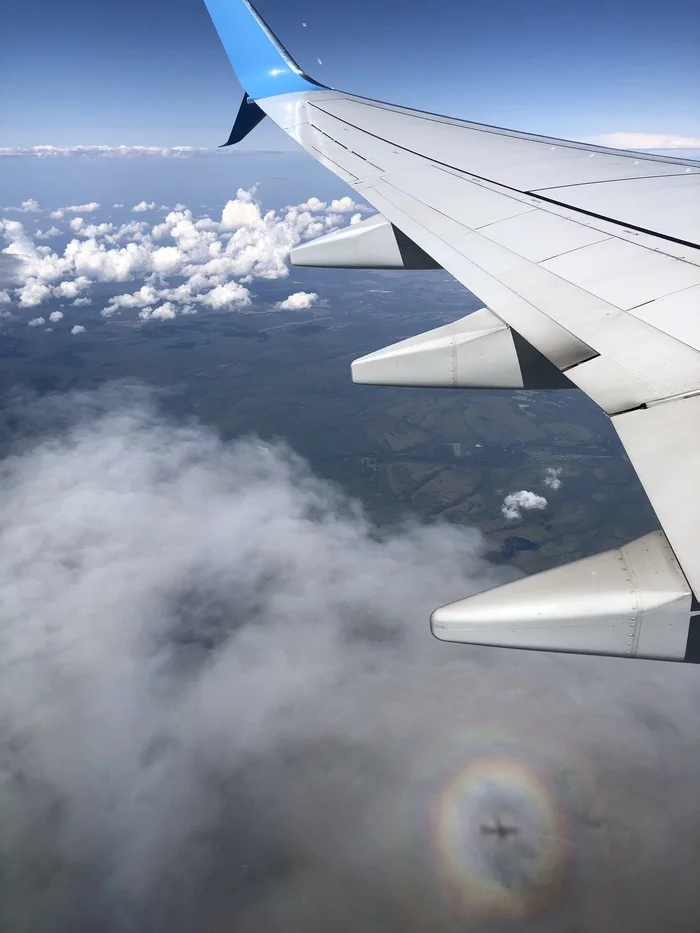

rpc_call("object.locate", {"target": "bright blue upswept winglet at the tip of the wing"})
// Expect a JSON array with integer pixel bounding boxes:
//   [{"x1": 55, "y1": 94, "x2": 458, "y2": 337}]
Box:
[{"x1": 204, "y1": 0, "x2": 325, "y2": 100}]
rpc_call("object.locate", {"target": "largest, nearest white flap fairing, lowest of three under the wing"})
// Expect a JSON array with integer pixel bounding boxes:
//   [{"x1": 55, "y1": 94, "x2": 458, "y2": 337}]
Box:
[{"x1": 431, "y1": 531, "x2": 691, "y2": 661}]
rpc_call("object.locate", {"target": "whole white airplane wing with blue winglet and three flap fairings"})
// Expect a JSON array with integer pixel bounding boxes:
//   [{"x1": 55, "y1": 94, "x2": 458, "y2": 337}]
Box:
[{"x1": 205, "y1": 0, "x2": 700, "y2": 661}]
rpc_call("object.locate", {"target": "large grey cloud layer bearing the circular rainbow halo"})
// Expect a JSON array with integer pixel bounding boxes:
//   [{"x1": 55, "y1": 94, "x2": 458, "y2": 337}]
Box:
[{"x1": 0, "y1": 387, "x2": 700, "y2": 933}]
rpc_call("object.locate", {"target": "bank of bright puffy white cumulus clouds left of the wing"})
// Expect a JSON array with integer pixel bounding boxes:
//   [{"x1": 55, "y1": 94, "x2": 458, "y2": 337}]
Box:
[{"x1": 0, "y1": 189, "x2": 372, "y2": 320}]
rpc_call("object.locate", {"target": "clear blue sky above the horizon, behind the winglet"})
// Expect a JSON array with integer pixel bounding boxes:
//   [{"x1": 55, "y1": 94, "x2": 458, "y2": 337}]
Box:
[{"x1": 5, "y1": 0, "x2": 700, "y2": 149}]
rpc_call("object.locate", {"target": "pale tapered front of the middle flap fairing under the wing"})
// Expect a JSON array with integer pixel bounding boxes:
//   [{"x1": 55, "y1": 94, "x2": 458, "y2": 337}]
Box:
[{"x1": 352, "y1": 308, "x2": 523, "y2": 389}]
